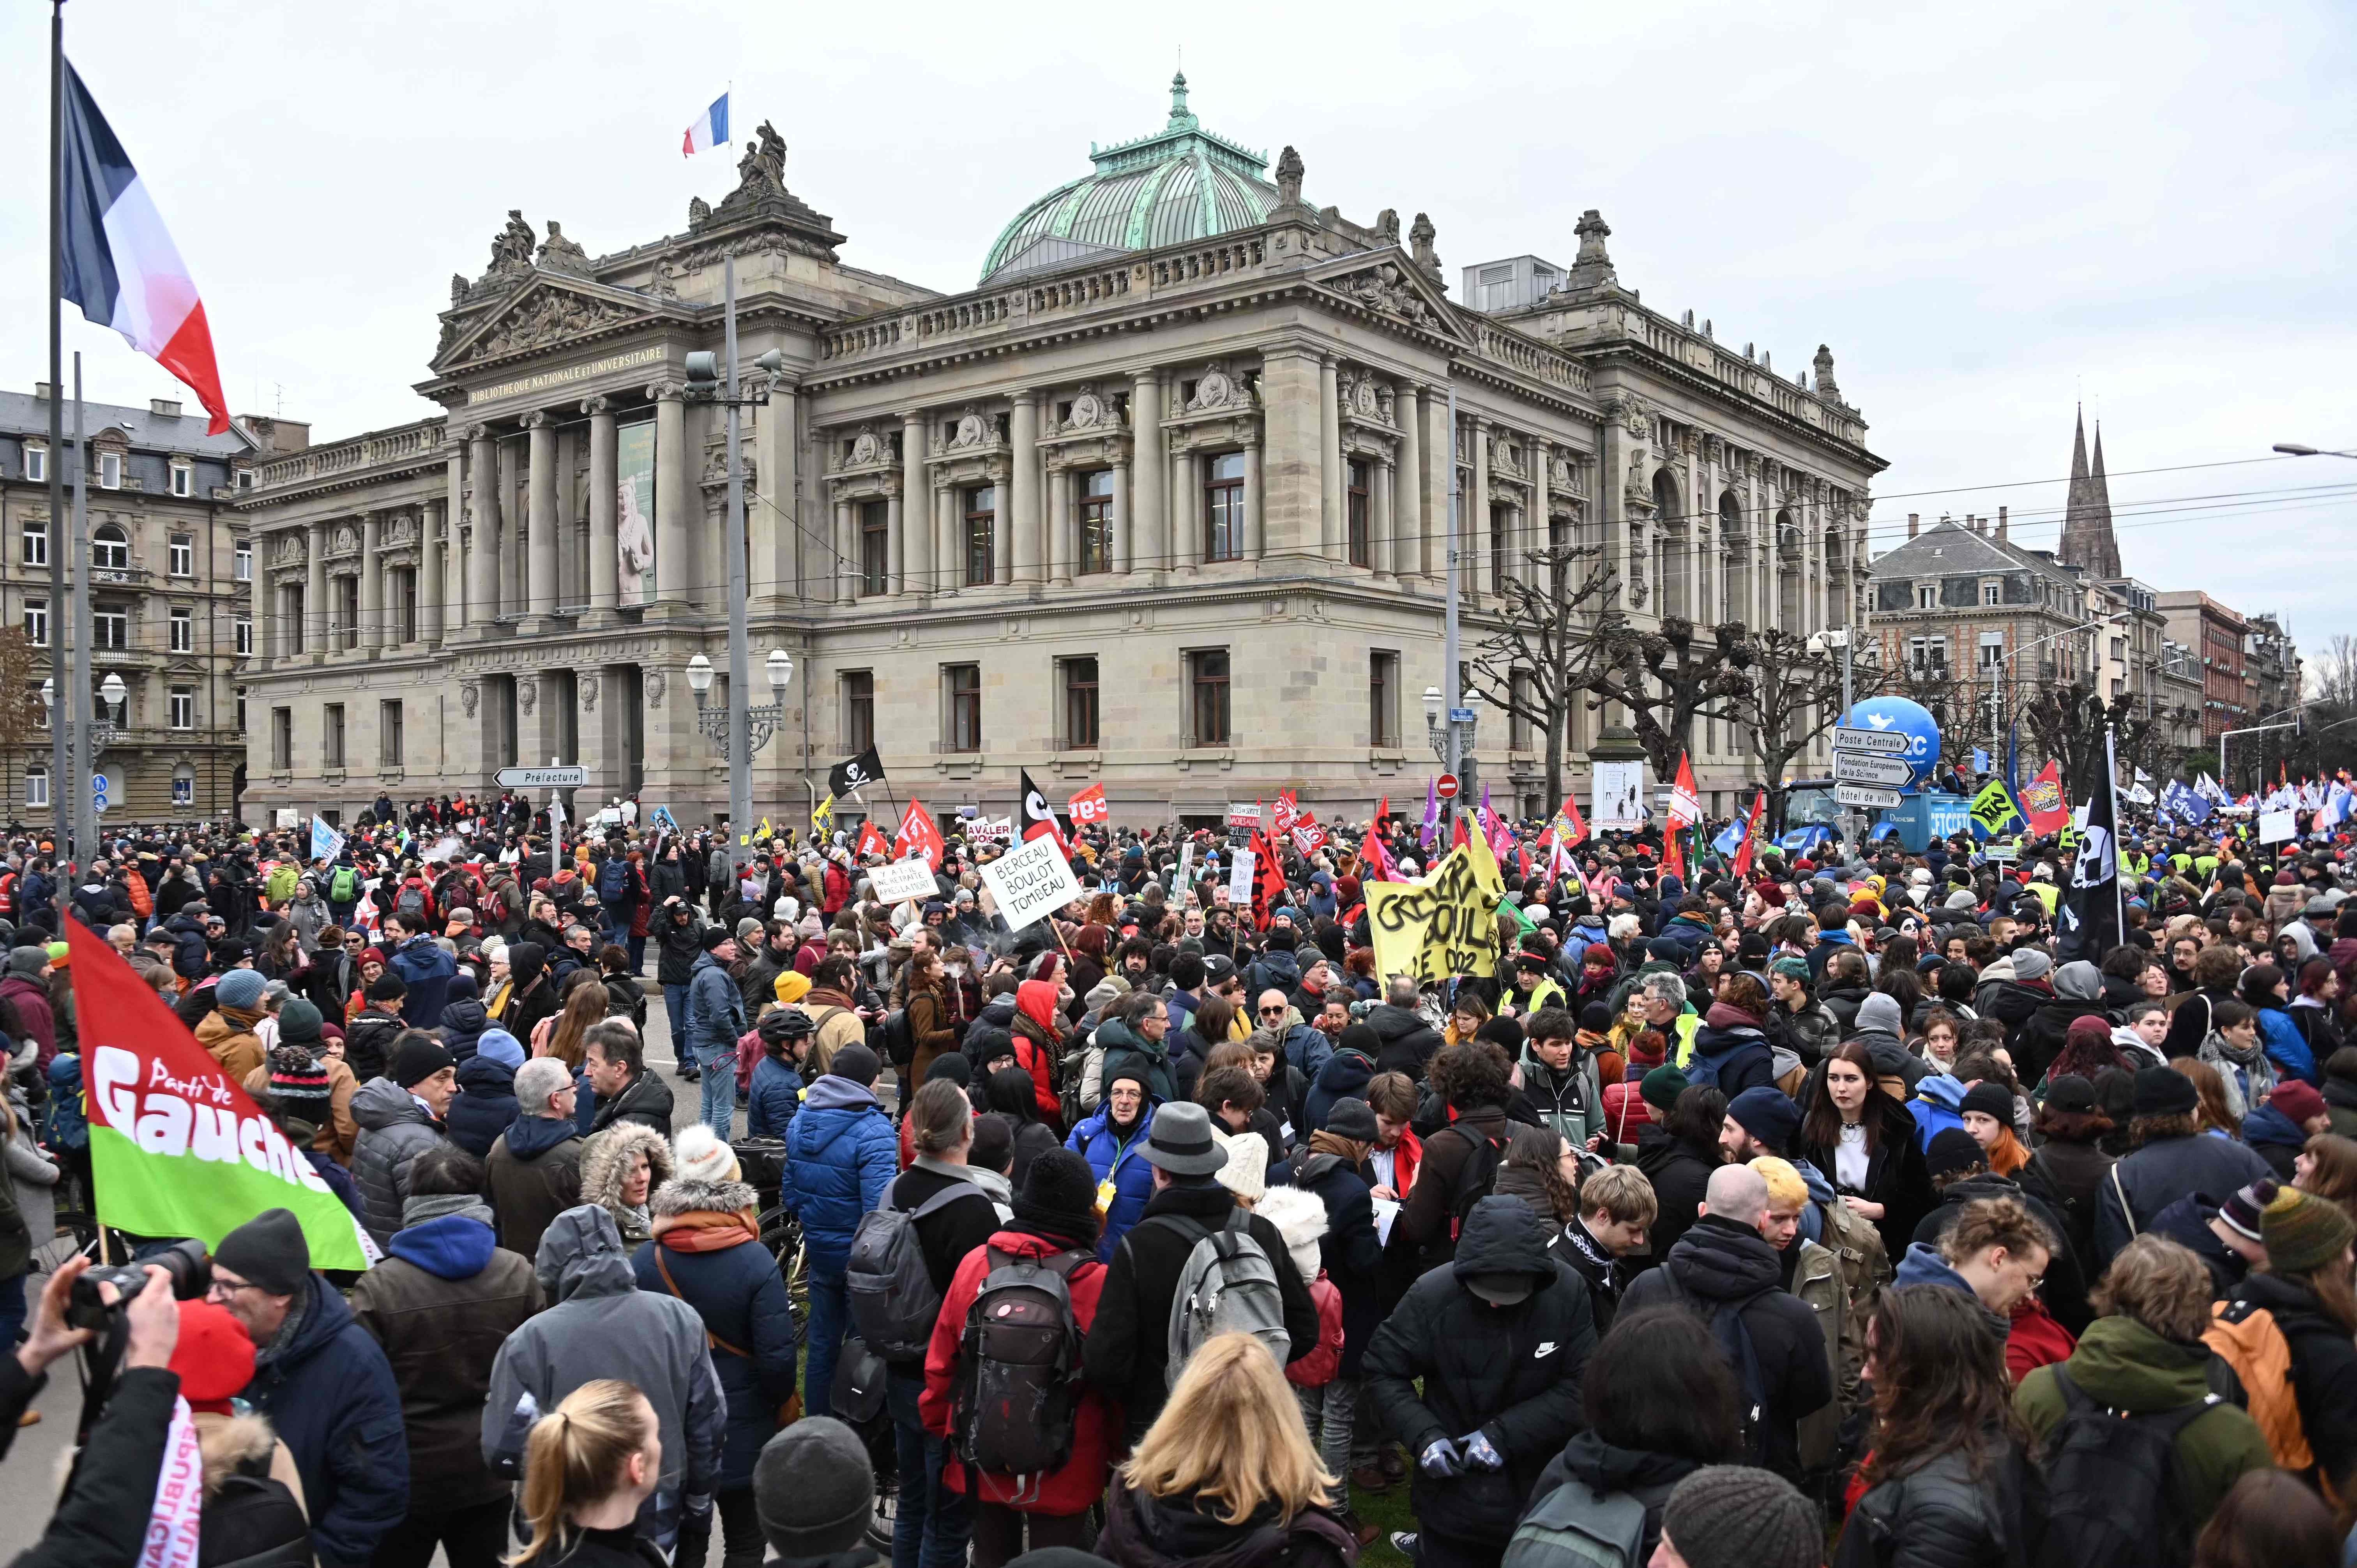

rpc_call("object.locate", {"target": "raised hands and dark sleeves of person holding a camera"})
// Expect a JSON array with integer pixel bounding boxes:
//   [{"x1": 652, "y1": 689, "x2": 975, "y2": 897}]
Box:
[{"x1": 0, "y1": 1257, "x2": 179, "y2": 1568}]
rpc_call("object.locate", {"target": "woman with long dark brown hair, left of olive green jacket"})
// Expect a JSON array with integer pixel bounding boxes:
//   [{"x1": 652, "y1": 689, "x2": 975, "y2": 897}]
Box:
[{"x1": 1834, "y1": 1285, "x2": 2032, "y2": 1568}]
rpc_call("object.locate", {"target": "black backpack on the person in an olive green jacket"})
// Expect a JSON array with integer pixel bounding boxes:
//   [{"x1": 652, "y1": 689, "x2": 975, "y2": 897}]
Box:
[{"x1": 2039, "y1": 1365, "x2": 2218, "y2": 1568}]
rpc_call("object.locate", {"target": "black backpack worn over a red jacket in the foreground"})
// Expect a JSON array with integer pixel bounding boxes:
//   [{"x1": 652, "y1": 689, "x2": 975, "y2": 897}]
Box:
[{"x1": 950, "y1": 1247, "x2": 1094, "y2": 1481}]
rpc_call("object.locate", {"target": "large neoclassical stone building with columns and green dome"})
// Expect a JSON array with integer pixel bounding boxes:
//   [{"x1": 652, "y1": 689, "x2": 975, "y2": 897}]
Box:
[{"x1": 243, "y1": 78, "x2": 1883, "y2": 823}]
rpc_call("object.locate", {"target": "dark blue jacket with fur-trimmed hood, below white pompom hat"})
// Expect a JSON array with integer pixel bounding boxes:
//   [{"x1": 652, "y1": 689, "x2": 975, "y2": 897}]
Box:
[{"x1": 629, "y1": 1181, "x2": 801, "y2": 1490}]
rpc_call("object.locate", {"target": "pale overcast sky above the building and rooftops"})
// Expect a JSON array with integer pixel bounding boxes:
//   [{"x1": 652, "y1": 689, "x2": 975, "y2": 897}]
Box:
[{"x1": 0, "y1": 0, "x2": 2357, "y2": 648}]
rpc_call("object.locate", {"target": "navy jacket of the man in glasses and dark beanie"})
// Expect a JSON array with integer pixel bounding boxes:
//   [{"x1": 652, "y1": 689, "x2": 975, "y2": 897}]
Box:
[{"x1": 245, "y1": 1273, "x2": 410, "y2": 1563}]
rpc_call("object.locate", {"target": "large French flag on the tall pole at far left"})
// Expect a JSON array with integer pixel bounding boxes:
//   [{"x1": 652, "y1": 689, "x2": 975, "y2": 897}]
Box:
[{"x1": 57, "y1": 64, "x2": 229, "y2": 436}]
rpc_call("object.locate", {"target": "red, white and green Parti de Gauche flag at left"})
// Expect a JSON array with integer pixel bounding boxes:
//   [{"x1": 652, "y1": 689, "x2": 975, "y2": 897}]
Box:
[{"x1": 66, "y1": 920, "x2": 377, "y2": 1269}]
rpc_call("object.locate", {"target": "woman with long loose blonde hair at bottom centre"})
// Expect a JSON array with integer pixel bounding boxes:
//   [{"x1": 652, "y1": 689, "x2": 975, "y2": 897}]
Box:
[{"x1": 1096, "y1": 1335, "x2": 1358, "y2": 1568}]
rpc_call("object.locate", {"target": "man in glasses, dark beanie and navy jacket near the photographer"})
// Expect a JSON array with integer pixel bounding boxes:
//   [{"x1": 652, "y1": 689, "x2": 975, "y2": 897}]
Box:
[{"x1": 205, "y1": 1210, "x2": 410, "y2": 1568}]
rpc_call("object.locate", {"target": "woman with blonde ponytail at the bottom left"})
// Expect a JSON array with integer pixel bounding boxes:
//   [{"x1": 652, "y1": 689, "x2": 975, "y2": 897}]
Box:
[{"x1": 504, "y1": 1377, "x2": 667, "y2": 1568}]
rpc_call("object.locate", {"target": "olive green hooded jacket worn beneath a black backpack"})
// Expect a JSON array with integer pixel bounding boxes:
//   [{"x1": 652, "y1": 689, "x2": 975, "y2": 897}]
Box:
[{"x1": 2013, "y1": 1318, "x2": 2274, "y2": 1521}]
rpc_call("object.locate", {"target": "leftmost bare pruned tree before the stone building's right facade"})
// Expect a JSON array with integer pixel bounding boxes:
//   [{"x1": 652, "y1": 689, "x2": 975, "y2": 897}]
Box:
[{"x1": 1466, "y1": 545, "x2": 1619, "y2": 809}]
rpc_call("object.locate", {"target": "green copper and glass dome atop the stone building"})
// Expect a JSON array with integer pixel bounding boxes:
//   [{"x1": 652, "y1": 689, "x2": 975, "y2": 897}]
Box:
[{"x1": 983, "y1": 71, "x2": 1277, "y2": 283}]
